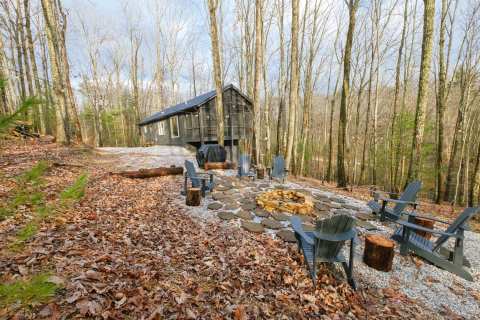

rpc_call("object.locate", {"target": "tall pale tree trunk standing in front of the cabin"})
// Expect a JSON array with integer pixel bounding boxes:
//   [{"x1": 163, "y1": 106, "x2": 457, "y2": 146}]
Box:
[{"x1": 208, "y1": 0, "x2": 225, "y2": 146}]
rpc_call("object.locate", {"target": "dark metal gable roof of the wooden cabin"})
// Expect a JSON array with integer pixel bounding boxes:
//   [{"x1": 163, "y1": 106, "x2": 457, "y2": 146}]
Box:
[{"x1": 138, "y1": 84, "x2": 246, "y2": 126}]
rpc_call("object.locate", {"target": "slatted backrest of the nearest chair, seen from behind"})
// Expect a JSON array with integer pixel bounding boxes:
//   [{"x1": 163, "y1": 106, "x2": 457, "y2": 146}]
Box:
[{"x1": 315, "y1": 214, "x2": 355, "y2": 259}]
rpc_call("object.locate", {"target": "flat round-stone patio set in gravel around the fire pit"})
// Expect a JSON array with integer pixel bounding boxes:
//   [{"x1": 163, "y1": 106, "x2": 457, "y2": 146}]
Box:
[{"x1": 182, "y1": 170, "x2": 376, "y2": 242}]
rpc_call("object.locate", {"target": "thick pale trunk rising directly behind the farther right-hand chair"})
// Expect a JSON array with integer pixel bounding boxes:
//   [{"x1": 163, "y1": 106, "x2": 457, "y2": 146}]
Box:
[{"x1": 407, "y1": 0, "x2": 435, "y2": 182}]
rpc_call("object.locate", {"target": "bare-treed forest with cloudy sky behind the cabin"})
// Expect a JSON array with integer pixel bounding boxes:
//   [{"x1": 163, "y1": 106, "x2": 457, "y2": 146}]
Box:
[{"x1": 0, "y1": 0, "x2": 480, "y2": 206}]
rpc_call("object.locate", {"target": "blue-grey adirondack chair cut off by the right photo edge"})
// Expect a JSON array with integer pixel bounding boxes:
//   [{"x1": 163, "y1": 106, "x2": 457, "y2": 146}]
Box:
[{"x1": 392, "y1": 207, "x2": 480, "y2": 281}]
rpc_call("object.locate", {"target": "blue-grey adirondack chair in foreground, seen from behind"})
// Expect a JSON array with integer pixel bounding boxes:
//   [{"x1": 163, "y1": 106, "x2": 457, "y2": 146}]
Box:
[{"x1": 290, "y1": 215, "x2": 357, "y2": 289}]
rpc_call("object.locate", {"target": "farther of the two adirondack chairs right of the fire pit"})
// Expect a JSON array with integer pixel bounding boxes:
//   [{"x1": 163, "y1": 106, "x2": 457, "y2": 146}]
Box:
[{"x1": 367, "y1": 180, "x2": 422, "y2": 221}]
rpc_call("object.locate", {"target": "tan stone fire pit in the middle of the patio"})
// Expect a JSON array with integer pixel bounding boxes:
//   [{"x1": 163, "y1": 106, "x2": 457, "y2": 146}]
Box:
[{"x1": 256, "y1": 189, "x2": 313, "y2": 215}]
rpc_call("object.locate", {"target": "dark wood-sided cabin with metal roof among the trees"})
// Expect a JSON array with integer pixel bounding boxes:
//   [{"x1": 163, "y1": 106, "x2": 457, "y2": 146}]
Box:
[{"x1": 139, "y1": 84, "x2": 253, "y2": 160}]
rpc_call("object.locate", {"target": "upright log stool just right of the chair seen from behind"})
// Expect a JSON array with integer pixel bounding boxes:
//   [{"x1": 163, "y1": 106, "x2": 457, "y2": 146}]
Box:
[{"x1": 363, "y1": 234, "x2": 395, "y2": 272}]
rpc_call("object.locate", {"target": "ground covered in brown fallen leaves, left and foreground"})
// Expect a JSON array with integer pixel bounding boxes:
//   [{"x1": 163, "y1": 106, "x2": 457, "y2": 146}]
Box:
[{"x1": 0, "y1": 142, "x2": 454, "y2": 319}]
